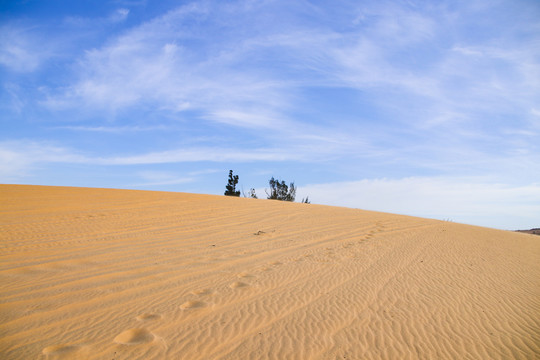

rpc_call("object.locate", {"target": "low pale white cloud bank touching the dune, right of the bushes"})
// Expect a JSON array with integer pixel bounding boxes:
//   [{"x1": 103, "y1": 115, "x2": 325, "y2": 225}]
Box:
[{"x1": 298, "y1": 177, "x2": 540, "y2": 229}]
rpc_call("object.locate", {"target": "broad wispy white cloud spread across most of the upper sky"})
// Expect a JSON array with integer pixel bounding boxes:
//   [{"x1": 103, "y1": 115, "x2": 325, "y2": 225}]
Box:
[{"x1": 40, "y1": 2, "x2": 540, "y2": 146}]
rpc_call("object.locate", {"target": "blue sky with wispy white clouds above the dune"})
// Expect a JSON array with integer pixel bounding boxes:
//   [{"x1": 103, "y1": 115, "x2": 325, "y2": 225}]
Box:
[{"x1": 0, "y1": 0, "x2": 540, "y2": 229}]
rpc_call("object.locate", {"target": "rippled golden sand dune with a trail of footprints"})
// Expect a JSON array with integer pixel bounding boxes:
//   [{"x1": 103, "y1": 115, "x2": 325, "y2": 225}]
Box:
[{"x1": 0, "y1": 185, "x2": 540, "y2": 360}]
